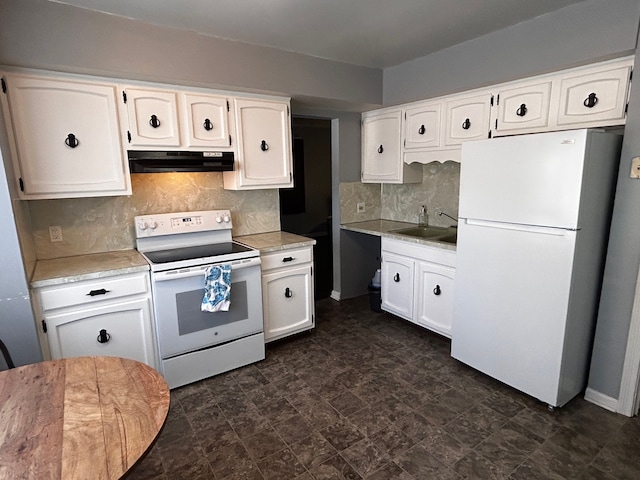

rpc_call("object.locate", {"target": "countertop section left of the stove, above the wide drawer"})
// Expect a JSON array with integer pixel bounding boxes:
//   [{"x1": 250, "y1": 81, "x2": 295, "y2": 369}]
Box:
[{"x1": 31, "y1": 249, "x2": 149, "y2": 288}]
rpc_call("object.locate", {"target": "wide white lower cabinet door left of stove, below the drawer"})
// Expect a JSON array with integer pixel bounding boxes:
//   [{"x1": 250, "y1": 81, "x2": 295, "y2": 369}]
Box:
[{"x1": 45, "y1": 298, "x2": 157, "y2": 368}]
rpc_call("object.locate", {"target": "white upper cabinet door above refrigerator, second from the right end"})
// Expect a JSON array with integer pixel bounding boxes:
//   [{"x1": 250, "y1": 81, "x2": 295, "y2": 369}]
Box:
[{"x1": 495, "y1": 80, "x2": 551, "y2": 134}]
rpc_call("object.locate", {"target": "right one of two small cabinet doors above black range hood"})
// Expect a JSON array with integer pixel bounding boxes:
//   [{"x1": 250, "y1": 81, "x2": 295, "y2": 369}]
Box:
[{"x1": 181, "y1": 94, "x2": 231, "y2": 148}]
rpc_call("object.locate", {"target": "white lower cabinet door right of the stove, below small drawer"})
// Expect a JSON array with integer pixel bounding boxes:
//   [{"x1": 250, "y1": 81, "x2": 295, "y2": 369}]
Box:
[{"x1": 262, "y1": 265, "x2": 314, "y2": 341}]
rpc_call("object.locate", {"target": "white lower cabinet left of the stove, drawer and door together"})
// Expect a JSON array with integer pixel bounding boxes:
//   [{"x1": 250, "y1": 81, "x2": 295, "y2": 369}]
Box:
[{"x1": 34, "y1": 272, "x2": 158, "y2": 368}]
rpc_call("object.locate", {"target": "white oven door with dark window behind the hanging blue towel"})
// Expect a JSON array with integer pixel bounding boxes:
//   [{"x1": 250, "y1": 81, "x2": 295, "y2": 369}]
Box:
[{"x1": 152, "y1": 258, "x2": 263, "y2": 359}]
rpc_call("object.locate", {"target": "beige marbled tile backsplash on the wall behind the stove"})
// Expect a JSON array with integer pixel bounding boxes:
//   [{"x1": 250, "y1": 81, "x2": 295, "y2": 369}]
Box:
[{"x1": 29, "y1": 172, "x2": 280, "y2": 259}]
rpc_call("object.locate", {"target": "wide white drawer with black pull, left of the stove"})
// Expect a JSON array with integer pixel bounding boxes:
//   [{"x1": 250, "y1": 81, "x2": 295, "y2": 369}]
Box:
[{"x1": 40, "y1": 274, "x2": 150, "y2": 311}]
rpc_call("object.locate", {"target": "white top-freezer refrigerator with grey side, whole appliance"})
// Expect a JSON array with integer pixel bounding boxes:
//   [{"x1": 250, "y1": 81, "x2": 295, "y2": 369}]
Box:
[{"x1": 451, "y1": 130, "x2": 621, "y2": 408}]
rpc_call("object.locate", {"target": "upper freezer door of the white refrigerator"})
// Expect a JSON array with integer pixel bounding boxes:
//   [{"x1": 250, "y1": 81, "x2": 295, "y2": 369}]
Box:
[{"x1": 459, "y1": 130, "x2": 589, "y2": 229}]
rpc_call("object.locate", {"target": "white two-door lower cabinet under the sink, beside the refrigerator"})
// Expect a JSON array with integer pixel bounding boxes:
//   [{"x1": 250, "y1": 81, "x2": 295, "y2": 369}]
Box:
[{"x1": 381, "y1": 238, "x2": 456, "y2": 338}]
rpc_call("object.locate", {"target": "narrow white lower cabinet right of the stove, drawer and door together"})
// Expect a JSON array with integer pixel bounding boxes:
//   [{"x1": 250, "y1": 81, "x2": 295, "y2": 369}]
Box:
[{"x1": 262, "y1": 247, "x2": 315, "y2": 342}]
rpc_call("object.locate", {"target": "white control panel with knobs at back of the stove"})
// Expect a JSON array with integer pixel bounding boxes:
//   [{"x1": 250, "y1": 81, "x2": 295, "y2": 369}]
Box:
[{"x1": 135, "y1": 210, "x2": 232, "y2": 238}]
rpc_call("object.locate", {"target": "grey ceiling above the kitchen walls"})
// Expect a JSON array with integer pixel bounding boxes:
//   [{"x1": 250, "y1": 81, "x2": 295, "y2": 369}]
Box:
[{"x1": 51, "y1": 0, "x2": 585, "y2": 68}]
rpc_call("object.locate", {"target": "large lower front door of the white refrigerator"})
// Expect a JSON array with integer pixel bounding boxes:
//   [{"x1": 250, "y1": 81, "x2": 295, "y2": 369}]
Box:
[{"x1": 451, "y1": 221, "x2": 579, "y2": 406}]
